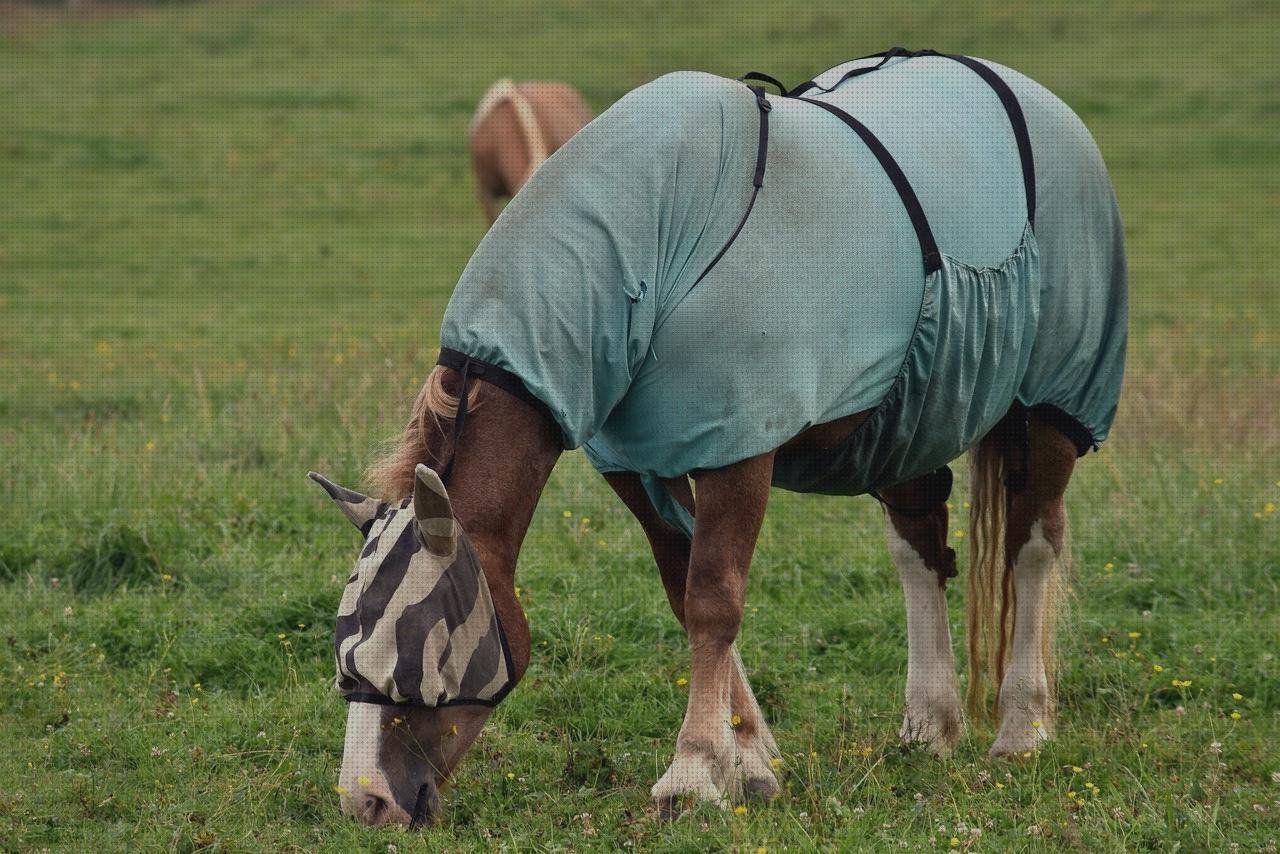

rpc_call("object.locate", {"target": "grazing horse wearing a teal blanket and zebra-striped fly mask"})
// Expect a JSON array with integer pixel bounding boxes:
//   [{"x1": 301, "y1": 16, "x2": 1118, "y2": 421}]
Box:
[{"x1": 314, "y1": 49, "x2": 1126, "y2": 823}]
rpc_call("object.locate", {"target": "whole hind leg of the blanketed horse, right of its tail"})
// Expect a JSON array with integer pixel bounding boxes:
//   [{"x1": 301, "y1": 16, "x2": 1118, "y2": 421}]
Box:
[{"x1": 991, "y1": 416, "x2": 1076, "y2": 755}]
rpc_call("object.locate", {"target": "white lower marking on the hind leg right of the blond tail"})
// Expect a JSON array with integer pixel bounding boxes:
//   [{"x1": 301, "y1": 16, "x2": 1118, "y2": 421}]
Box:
[{"x1": 991, "y1": 521, "x2": 1057, "y2": 755}]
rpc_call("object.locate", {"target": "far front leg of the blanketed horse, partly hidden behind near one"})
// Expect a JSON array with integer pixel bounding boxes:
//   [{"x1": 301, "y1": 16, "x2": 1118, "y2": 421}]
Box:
[{"x1": 604, "y1": 472, "x2": 780, "y2": 800}]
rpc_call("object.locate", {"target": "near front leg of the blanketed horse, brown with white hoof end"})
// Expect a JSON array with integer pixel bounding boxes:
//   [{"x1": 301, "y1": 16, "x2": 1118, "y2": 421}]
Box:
[{"x1": 640, "y1": 453, "x2": 773, "y2": 810}]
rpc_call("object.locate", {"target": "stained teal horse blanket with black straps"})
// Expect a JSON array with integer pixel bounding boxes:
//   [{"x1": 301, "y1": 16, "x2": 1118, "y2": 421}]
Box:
[{"x1": 440, "y1": 49, "x2": 1126, "y2": 531}]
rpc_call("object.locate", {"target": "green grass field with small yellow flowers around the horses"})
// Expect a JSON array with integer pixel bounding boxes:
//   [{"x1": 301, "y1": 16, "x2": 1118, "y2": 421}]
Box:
[{"x1": 0, "y1": 0, "x2": 1280, "y2": 851}]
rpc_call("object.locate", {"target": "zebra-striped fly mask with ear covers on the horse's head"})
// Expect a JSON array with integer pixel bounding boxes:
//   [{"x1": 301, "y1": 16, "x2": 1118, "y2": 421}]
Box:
[{"x1": 307, "y1": 465, "x2": 515, "y2": 707}]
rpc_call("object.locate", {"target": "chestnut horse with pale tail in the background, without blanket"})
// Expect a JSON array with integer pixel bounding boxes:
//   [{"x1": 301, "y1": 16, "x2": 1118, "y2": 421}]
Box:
[{"x1": 470, "y1": 78, "x2": 591, "y2": 225}]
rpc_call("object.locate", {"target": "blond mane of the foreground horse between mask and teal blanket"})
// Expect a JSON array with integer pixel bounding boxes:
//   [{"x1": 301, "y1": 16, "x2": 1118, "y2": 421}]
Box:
[{"x1": 365, "y1": 365, "x2": 484, "y2": 501}]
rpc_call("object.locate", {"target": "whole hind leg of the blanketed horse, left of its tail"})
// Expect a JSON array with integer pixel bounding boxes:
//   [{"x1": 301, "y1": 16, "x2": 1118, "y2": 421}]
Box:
[{"x1": 881, "y1": 475, "x2": 963, "y2": 757}]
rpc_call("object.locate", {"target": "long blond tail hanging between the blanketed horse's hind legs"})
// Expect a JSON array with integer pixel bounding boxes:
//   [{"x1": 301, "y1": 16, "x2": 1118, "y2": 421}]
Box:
[{"x1": 965, "y1": 430, "x2": 1015, "y2": 718}]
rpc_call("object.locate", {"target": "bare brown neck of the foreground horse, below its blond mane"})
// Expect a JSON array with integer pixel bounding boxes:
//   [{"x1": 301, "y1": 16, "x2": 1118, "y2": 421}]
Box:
[{"x1": 448, "y1": 385, "x2": 563, "y2": 679}]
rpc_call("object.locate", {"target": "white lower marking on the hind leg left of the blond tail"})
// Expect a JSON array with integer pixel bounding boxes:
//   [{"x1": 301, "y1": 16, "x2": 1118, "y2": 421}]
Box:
[{"x1": 884, "y1": 517, "x2": 963, "y2": 757}]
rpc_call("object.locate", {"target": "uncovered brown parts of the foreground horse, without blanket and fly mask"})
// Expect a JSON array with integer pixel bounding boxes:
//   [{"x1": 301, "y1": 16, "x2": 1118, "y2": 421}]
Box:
[{"x1": 327, "y1": 376, "x2": 1076, "y2": 825}]
